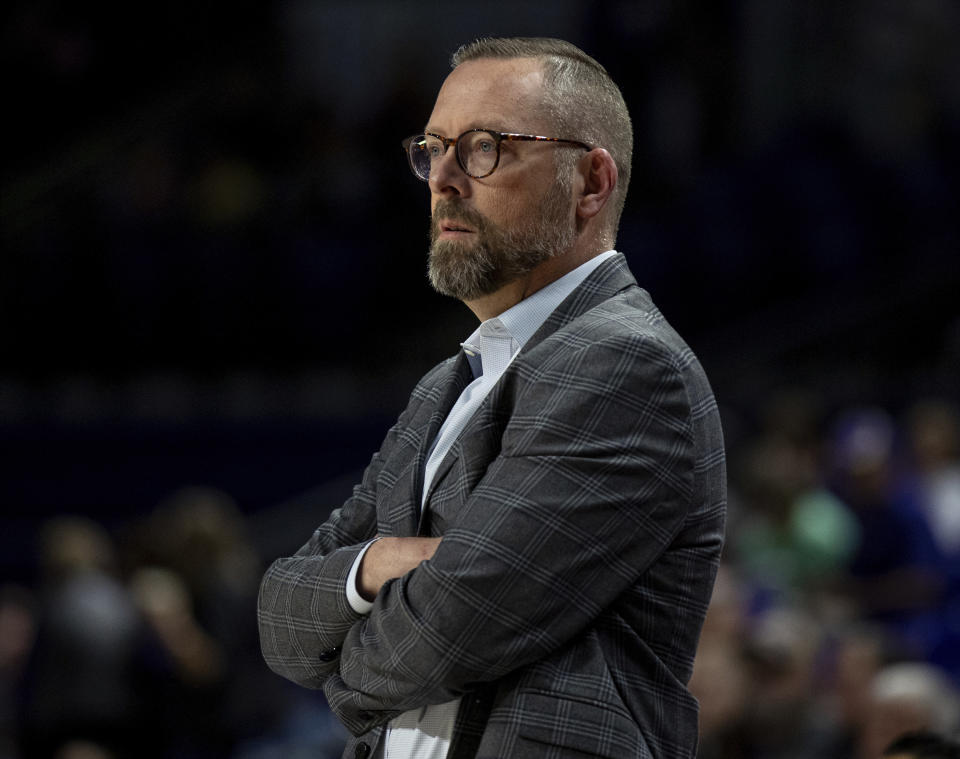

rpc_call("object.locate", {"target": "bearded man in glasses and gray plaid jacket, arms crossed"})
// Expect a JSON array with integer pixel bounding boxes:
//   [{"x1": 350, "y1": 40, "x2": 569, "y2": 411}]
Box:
[{"x1": 259, "y1": 39, "x2": 725, "y2": 759}]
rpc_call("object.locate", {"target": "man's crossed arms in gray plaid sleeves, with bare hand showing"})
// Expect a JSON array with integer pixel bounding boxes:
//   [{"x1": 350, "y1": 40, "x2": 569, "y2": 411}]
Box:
[{"x1": 259, "y1": 334, "x2": 694, "y2": 734}]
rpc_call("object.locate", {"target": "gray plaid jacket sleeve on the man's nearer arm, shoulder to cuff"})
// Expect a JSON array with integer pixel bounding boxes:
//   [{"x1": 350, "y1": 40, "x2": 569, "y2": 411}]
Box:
[{"x1": 325, "y1": 334, "x2": 697, "y2": 733}]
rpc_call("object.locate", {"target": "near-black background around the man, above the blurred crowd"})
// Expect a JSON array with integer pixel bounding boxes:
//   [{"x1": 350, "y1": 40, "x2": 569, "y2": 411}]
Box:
[{"x1": 0, "y1": 0, "x2": 960, "y2": 759}]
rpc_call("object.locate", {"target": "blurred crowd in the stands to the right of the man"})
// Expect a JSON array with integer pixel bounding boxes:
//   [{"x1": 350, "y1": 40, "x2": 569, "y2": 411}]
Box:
[{"x1": 691, "y1": 392, "x2": 960, "y2": 759}]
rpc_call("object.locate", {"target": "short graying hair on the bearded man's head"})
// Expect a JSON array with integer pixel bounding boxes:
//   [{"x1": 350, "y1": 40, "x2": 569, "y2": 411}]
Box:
[{"x1": 450, "y1": 37, "x2": 633, "y2": 238}]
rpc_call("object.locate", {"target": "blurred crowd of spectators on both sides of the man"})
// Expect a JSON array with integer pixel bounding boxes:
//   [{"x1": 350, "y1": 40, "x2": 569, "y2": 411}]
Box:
[{"x1": 0, "y1": 391, "x2": 960, "y2": 759}]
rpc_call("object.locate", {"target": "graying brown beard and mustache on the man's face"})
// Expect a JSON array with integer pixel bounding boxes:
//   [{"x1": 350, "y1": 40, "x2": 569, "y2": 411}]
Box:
[{"x1": 428, "y1": 187, "x2": 576, "y2": 301}]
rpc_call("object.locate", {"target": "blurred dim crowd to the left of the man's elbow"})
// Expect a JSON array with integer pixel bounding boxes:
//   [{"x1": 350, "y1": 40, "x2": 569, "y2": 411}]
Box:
[{"x1": 0, "y1": 488, "x2": 352, "y2": 759}]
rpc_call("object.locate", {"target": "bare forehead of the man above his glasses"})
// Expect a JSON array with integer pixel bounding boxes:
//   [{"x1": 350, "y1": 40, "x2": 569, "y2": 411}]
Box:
[{"x1": 427, "y1": 58, "x2": 546, "y2": 136}]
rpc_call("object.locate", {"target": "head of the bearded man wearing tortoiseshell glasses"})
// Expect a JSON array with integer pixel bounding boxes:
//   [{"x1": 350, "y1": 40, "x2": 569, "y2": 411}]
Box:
[{"x1": 421, "y1": 38, "x2": 633, "y2": 310}]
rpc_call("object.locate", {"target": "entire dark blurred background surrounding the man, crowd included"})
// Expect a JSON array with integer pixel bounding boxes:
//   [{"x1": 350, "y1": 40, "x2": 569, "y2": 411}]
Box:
[{"x1": 0, "y1": 0, "x2": 960, "y2": 759}]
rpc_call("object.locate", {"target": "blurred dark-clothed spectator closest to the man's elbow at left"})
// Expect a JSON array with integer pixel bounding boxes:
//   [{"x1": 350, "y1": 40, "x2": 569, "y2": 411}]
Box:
[{"x1": 128, "y1": 487, "x2": 288, "y2": 746}]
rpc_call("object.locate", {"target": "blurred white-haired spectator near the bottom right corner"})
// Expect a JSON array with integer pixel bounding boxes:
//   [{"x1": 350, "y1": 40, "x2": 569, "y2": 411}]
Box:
[{"x1": 857, "y1": 662, "x2": 960, "y2": 759}]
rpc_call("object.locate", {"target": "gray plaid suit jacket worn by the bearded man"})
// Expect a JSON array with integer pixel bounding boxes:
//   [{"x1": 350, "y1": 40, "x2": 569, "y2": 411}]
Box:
[{"x1": 259, "y1": 255, "x2": 726, "y2": 759}]
